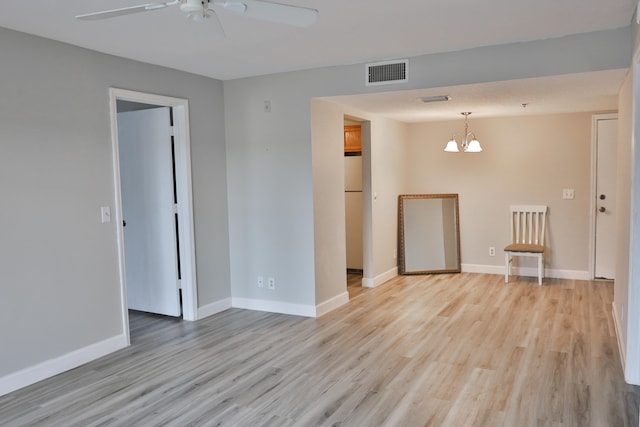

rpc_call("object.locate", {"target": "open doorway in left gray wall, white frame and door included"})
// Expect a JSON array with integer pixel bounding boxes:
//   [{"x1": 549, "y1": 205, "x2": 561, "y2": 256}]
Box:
[{"x1": 110, "y1": 89, "x2": 197, "y2": 343}]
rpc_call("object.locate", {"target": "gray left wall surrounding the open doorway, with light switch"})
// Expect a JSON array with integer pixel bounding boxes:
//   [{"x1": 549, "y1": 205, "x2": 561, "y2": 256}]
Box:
[{"x1": 0, "y1": 28, "x2": 230, "y2": 377}]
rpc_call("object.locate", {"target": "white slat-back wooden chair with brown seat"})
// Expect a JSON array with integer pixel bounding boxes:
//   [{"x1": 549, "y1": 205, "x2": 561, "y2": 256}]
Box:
[{"x1": 504, "y1": 205, "x2": 547, "y2": 285}]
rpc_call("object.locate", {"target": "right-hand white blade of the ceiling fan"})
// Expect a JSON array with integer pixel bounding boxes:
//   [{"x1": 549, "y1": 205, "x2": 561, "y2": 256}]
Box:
[{"x1": 221, "y1": 0, "x2": 318, "y2": 27}]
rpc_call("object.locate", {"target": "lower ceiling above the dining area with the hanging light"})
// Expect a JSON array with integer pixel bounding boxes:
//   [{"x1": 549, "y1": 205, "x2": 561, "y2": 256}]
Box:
[{"x1": 328, "y1": 70, "x2": 627, "y2": 123}]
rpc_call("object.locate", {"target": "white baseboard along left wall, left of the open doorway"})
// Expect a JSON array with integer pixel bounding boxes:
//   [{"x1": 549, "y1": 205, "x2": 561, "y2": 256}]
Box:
[{"x1": 0, "y1": 335, "x2": 127, "y2": 396}]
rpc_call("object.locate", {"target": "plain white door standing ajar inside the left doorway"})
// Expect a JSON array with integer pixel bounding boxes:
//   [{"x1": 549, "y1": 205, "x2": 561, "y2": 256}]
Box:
[{"x1": 118, "y1": 107, "x2": 181, "y2": 316}]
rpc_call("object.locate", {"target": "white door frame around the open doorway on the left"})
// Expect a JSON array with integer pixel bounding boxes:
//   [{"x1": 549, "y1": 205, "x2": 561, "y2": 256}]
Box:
[{"x1": 109, "y1": 88, "x2": 198, "y2": 344}]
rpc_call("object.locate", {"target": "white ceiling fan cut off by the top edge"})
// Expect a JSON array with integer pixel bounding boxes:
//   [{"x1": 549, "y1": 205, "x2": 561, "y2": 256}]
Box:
[{"x1": 76, "y1": 0, "x2": 318, "y2": 27}]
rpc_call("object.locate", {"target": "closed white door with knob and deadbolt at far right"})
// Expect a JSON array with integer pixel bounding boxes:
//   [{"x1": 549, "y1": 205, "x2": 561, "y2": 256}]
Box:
[{"x1": 594, "y1": 117, "x2": 618, "y2": 279}]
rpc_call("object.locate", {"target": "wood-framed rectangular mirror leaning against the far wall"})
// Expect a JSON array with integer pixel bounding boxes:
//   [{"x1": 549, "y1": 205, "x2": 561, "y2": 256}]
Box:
[{"x1": 398, "y1": 194, "x2": 460, "y2": 274}]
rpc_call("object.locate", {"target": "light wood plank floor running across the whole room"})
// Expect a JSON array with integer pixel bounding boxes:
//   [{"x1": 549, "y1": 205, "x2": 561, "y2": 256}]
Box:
[{"x1": 0, "y1": 273, "x2": 640, "y2": 427}]
